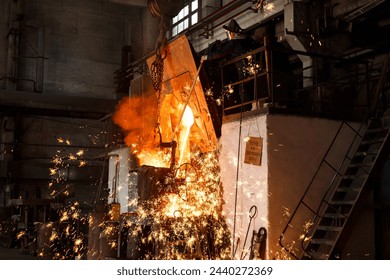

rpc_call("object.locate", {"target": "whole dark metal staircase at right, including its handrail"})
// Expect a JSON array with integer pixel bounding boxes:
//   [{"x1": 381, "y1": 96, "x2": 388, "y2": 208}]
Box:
[{"x1": 279, "y1": 58, "x2": 390, "y2": 260}]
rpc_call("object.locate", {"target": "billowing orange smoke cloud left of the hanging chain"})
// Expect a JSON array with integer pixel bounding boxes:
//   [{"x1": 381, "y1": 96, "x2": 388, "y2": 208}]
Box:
[{"x1": 113, "y1": 94, "x2": 158, "y2": 149}]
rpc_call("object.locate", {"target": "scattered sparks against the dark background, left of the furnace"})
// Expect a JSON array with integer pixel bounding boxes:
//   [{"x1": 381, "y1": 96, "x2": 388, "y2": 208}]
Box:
[{"x1": 45, "y1": 123, "x2": 108, "y2": 259}]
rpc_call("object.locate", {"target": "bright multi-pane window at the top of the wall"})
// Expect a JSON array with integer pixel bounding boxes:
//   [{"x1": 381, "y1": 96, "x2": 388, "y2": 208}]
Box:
[{"x1": 172, "y1": 0, "x2": 201, "y2": 37}]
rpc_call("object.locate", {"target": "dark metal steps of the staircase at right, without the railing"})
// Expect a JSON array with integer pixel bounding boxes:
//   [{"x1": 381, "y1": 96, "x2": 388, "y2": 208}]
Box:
[{"x1": 302, "y1": 121, "x2": 390, "y2": 259}]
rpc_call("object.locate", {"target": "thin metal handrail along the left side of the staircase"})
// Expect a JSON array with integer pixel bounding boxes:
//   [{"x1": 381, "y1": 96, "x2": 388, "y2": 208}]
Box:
[{"x1": 279, "y1": 55, "x2": 389, "y2": 259}]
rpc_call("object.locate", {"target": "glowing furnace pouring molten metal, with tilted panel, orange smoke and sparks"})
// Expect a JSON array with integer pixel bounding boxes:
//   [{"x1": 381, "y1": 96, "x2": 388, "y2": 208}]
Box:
[{"x1": 111, "y1": 36, "x2": 230, "y2": 259}]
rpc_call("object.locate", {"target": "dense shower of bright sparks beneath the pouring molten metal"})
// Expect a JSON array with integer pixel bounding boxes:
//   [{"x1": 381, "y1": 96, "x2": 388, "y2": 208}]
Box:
[{"x1": 132, "y1": 152, "x2": 230, "y2": 259}]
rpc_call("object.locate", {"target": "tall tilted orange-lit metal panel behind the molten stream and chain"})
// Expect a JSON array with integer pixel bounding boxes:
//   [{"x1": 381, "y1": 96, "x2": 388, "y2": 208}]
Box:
[{"x1": 147, "y1": 35, "x2": 218, "y2": 152}]
